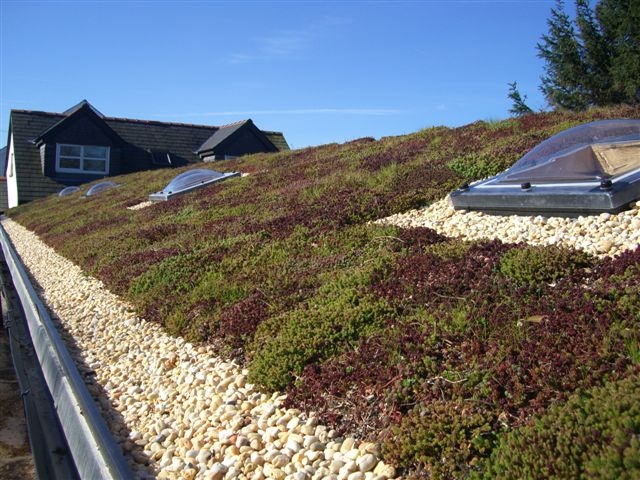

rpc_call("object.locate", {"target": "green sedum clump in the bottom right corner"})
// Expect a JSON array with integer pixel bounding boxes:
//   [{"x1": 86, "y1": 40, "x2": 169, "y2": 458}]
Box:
[{"x1": 476, "y1": 372, "x2": 640, "y2": 480}]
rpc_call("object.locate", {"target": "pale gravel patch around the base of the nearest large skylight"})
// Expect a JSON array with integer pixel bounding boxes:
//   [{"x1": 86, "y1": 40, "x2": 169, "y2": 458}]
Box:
[{"x1": 376, "y1": 198, "x2": 640, "y2": 256}]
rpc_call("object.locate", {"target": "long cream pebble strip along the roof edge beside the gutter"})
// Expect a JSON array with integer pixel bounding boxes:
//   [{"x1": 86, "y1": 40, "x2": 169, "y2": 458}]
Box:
[{"x1": 2, "y1": 219, "x2": 396, "y2": 480}]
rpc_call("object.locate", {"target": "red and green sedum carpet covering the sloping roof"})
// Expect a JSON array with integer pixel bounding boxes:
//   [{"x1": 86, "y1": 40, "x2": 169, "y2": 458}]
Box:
[{"x1": 9, "y1": 107, "x2": 640, "y2": 478}]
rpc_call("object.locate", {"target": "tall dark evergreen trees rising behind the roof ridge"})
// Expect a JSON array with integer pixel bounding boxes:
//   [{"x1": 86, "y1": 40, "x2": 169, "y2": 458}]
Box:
[{"x1": 537, "y1": 0, "x2": 640, "y2": 110}]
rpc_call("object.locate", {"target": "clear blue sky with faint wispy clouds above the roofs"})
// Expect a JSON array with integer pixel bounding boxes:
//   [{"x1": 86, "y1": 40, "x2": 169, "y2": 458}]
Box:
[{"x1": 0, "y1": 0, "x2": 555, "y2": 148}]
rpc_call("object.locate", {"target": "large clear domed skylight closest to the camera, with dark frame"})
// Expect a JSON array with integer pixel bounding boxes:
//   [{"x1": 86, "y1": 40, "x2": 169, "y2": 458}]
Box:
[{"x1": 451, "y1": 120, "x2": 640, "y2": 216}]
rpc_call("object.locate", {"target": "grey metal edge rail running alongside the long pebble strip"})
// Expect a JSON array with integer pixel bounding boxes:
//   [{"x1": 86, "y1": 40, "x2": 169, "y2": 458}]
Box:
[{"x1": 0, "y1": 222, "x2": 133, "y2": 479}]
